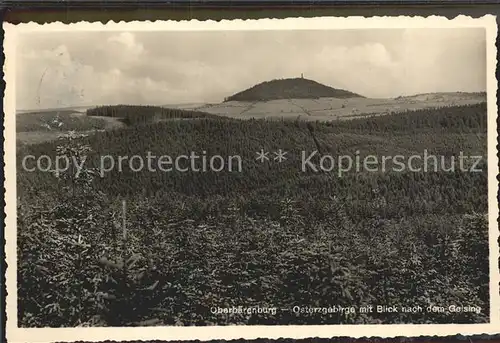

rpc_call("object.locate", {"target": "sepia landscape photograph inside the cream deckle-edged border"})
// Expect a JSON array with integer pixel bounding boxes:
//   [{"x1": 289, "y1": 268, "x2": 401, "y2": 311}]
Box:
[{"x1": 4, "y1": 15, "x2": 498, "y2": 336}]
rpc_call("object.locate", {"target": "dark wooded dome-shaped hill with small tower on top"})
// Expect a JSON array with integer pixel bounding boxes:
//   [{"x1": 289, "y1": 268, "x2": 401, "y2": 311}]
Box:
[{"x1": 224, "y1": 77, "x2": 364, "y2": 102}]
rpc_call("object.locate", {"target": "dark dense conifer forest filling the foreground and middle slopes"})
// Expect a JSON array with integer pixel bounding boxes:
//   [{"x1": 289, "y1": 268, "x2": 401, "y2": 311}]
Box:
[{"x1": 17, "y1": 104, "x2": 489, "y2": 327}]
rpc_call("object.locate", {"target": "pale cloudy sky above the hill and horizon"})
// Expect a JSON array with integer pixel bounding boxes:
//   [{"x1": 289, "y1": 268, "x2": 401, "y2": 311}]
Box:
[{"x1": 16, "y1": 29, "x2": 486, "y2": 109}]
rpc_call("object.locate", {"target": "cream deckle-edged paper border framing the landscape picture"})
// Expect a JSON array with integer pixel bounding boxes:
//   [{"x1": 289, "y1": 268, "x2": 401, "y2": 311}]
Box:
[{"x1": 3, "y1": 15, "x2": 500, "y2": 343}]
